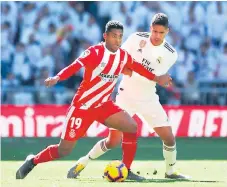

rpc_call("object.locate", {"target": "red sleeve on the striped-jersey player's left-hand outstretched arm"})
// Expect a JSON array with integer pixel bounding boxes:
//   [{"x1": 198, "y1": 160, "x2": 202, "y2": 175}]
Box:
[{"x1": 57, "y1": 47, "x2": 96, "y2": 80}]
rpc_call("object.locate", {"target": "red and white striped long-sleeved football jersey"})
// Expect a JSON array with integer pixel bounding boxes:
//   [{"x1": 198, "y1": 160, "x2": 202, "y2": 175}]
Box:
[{"x1": 57, "y1": 43, "x2": 154, "y2": 109}]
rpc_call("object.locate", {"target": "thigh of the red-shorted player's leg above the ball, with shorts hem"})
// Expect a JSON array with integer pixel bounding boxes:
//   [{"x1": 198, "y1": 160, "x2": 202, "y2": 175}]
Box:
[{"x1": 97, "y1": 102, "x2": 137, "y2": 133}]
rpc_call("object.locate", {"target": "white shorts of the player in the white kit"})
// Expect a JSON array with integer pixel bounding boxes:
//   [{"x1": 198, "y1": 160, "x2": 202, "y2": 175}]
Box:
[{"x1": 116, "y1": 93, "x2": 170, "y2": 132}]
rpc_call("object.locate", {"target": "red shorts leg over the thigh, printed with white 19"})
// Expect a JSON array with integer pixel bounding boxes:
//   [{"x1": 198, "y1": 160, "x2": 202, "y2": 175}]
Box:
[{"x1": 61, "y1": 106, "x2": 94, "y2": 142}]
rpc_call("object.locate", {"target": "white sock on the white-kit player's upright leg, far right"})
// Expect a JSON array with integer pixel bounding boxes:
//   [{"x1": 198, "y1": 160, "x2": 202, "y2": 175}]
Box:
[{"x1": 163, "y1": 143, "x2": 177, "y2": 175}]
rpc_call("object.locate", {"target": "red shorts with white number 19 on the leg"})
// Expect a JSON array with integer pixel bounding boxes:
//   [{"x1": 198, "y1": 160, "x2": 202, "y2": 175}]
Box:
[{"x1": 61, "y1": 101, "x2": 122, "y2": 141}]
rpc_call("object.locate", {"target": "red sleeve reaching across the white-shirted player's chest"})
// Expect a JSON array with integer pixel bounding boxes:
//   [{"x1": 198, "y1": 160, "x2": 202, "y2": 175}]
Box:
[{"x1": 125, "y1": 54, "x2": 155, "y2": 80}]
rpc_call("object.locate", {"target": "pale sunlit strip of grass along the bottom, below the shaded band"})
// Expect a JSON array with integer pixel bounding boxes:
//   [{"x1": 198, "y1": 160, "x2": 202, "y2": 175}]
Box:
[{"x1": 1, "y1": 161, "x2": 227, "y2": 187}]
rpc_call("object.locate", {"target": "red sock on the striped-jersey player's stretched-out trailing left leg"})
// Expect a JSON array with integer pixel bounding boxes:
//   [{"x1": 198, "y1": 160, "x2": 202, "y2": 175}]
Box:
[{"x1": 33, "y1": 144, "x2": 59, "y2": 164}]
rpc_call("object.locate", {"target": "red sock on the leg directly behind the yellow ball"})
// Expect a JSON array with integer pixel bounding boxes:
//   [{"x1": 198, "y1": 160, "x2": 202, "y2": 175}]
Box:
[{"x1": 122, "y1": 133, "x2": 137, "y2": 169}]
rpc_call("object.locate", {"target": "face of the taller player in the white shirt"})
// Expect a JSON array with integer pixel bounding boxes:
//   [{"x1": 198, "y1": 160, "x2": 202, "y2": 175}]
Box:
[{"x1": 150, "y1": 25, "x2": 169, "y2": 45}]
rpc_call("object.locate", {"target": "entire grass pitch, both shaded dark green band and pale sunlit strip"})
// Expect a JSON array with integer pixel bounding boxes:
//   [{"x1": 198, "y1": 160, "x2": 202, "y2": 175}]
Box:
[{"x1": 1, "y1": 138, "x2": 227, "y2": 187}]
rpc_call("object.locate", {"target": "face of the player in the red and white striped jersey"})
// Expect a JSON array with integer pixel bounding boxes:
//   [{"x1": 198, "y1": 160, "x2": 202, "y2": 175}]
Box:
[{"x1": 103, "y1": 29, "x2": 123, "y2": 52}]
